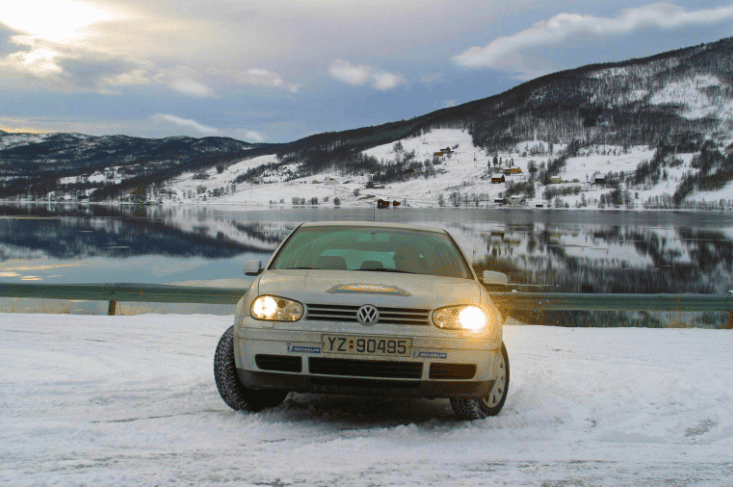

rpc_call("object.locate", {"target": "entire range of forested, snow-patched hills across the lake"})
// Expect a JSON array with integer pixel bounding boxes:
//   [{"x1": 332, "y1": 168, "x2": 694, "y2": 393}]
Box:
[{"x1": 0, "y1": 35, "x2": 733, "y2": 209}]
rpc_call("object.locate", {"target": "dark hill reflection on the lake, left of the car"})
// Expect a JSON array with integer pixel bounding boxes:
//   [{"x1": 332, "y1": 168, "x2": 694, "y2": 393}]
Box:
[{"x1": 0, "y1": 207, "x2": 292, "y2": 261}]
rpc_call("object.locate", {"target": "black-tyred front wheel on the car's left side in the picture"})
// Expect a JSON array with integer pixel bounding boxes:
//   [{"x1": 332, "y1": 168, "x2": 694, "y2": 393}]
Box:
[{"x1": 214, "y1": 326, "x2": 288, "y2": 412}]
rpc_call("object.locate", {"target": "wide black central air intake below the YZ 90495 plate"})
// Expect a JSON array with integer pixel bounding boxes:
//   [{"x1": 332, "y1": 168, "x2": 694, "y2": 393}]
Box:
[{"x1": 308, "y1": 357, "x2": 423, "y2": 379}]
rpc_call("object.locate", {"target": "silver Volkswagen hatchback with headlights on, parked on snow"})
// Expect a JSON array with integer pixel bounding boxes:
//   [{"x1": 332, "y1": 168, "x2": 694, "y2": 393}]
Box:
[{"x1": 214, "y1": 222, "x2": 509, "y2": 419}]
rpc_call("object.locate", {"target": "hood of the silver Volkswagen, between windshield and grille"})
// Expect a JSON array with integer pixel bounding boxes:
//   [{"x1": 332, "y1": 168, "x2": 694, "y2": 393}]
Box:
[{"x1": 257, "y1": 269, "x2": 482, "y2": 309}]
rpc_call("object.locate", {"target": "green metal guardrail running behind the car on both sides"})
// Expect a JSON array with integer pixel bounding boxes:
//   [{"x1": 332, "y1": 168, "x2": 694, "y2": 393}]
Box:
[{"x1": 0, "y1": 283, "x2": 733, "y2": 329}]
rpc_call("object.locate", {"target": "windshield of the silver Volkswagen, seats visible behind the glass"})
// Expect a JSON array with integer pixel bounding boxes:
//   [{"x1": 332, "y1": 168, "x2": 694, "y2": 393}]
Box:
[{"x1": 270, "y1": 226, "x2": 473, "y2": 279}]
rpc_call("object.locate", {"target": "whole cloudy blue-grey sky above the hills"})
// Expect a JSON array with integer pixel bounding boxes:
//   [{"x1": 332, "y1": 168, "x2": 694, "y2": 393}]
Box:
[{"x1": 0, "y1": 0, "x2": 733, "y2": 142}]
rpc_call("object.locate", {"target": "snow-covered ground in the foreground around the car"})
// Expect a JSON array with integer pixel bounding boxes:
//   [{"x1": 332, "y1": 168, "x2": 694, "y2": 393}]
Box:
[{"x1": 0, "y1": 314, "x2": 733, "y2": 487}]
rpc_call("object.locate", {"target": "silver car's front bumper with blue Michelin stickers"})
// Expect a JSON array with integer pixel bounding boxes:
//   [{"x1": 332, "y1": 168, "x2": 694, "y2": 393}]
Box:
[{"x1": 234, "y1": 328, "x2": 500, "y2": 398}]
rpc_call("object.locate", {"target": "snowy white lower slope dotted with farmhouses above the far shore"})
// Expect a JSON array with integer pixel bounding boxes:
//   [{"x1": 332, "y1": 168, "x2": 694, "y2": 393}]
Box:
[{"x1": 150, "y1": 129, "x2": 733, "y2": 213}]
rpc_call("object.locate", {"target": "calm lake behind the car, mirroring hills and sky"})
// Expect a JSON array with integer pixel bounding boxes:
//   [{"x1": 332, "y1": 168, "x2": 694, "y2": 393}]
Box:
[{"x1": 0, "y1": 204, "x2": 733, "y2": 322}]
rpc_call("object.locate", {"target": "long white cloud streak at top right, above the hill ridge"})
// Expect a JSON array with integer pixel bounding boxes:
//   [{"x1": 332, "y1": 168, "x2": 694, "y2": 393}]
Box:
[{"x1": 453, "y1": 3, "x2": 733, "y2": 75}]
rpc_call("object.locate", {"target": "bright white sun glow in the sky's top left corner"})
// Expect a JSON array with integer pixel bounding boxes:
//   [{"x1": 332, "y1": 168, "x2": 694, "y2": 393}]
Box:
[{"x1": 0, "y1": 0, "x2": 113, "y2": 42}]
